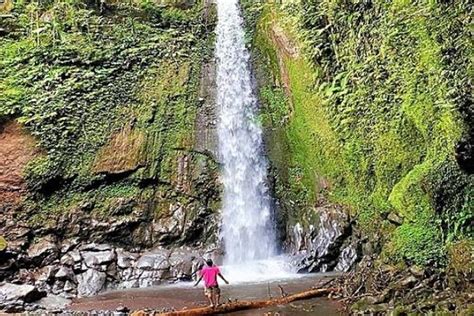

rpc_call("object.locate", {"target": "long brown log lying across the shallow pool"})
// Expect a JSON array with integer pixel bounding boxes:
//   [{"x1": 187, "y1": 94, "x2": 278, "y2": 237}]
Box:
[{"x1": 155, "y1": 288, "x2": 339, "y2": 316}]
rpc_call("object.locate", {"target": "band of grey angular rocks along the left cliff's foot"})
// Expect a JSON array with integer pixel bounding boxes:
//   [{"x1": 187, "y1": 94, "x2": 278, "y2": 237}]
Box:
[{"x1": 0, "y1": 241, "x2": 215, "y2": 312}]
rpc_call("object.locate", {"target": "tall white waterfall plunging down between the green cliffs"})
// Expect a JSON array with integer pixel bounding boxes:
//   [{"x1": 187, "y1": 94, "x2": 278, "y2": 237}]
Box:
[{"x1": 216, "y1": 0, "x2": 295, "y2": 282}]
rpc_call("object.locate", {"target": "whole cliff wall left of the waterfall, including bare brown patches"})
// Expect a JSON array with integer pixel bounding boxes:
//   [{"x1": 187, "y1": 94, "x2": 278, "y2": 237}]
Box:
[{"x1": 0, "y1": 1, "x2": 219, "y2": 250}]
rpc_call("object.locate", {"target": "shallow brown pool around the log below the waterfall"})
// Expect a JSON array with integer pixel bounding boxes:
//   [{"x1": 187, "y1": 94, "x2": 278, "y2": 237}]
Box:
[{"x1": 69, "y1": 274, "x2": 343, "y2": 316}]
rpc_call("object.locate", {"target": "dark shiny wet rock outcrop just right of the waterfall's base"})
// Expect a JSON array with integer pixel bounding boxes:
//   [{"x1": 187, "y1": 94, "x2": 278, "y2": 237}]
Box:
[{"x1": 289, "y1": 206, "x2": 360, "y2": 272}]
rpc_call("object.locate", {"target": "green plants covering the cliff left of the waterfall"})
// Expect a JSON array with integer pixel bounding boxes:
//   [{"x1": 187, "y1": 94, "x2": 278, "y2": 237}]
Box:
[{"x1": 0, "y1": 0, "x2": 214, "y2": 217}]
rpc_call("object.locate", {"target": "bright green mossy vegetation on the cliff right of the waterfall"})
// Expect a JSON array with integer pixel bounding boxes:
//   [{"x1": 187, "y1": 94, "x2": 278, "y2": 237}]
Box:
[{"x1": 246, "y1": 0, "x2": 474, "y2": 265}]
